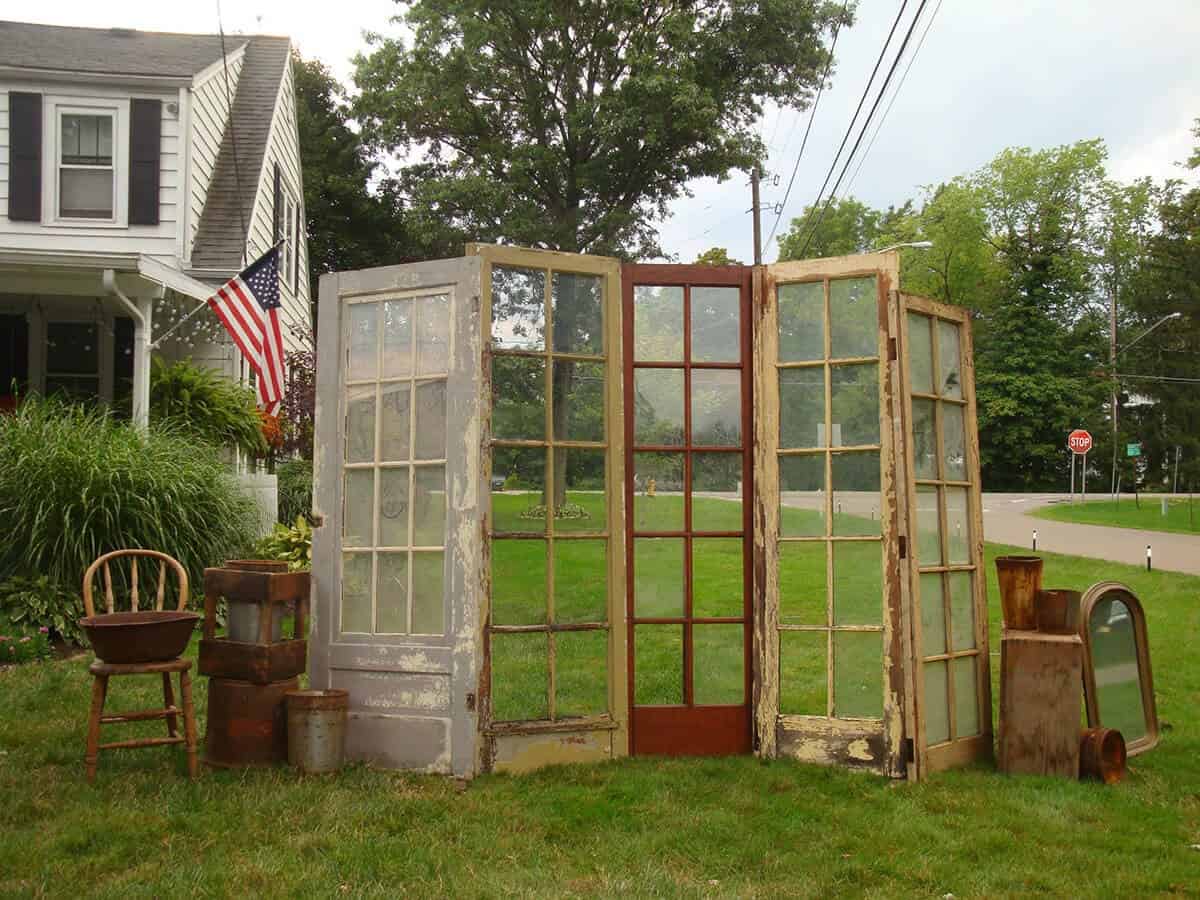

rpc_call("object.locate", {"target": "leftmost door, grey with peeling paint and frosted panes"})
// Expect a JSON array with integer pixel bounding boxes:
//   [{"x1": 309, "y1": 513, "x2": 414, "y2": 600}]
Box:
[{"x1": 310, "y1": 258, "x2": 486, "y2": 776}]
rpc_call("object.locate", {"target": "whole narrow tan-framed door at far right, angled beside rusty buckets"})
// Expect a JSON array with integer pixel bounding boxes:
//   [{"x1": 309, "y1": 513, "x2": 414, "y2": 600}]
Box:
[{"x1": 899, "y1": 294, "x2": 992, "y2": 776}]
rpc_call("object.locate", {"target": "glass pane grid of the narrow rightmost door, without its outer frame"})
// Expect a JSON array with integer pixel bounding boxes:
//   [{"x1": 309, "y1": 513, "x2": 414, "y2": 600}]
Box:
[{"x1": 905, "y1": 310, "x2": 988, "y2": 748}]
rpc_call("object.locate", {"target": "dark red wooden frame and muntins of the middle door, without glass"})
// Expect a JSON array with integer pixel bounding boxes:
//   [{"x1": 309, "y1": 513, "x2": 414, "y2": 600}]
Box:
[{"x1": 620, "y1": 263, "x2": 756, "y2": 755}]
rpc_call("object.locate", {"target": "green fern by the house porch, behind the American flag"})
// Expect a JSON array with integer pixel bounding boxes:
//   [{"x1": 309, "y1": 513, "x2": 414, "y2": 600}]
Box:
[{"x1": 150, "y1": 356, "x2": 268, "y2": 457}]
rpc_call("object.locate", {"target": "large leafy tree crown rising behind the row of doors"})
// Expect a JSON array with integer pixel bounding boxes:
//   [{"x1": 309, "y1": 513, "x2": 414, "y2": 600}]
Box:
[{"x1": 354, "y1": 0, "x2": 851, "y2": 258}]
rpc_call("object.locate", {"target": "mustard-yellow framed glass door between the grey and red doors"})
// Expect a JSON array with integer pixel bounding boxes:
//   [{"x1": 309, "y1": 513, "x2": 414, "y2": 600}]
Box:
[{"x1": 467, "y1": 245, "x2": 629, "y2": 770}]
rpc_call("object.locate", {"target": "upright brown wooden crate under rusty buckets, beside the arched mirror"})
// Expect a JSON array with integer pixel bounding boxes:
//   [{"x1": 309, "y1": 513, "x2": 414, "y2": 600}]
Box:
[{"x1": 998, "y1": 630, "x2": 1084, "y2": 779}]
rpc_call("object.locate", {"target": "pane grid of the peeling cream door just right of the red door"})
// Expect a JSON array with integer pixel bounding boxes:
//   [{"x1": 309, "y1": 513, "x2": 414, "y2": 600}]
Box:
[{"x1": 774, "y1": 275, "x2": 888, "y2": 721}]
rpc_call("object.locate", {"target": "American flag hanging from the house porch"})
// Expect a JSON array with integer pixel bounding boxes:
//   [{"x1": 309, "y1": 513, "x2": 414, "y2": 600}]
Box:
[{"x1": 209, "y1": 245, "x2": 284, "y2": 415}]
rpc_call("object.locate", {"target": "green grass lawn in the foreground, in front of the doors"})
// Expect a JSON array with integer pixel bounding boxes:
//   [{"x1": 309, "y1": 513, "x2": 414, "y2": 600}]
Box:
[{"x1": 0, "y1": 546, "x2": 1200, "y2": 898}]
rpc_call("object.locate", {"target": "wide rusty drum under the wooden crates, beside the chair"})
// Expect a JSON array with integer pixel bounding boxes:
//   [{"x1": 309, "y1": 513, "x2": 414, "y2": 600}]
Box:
[{"x1": 204, "y1": 678, "x2": 300, "y2": 766}]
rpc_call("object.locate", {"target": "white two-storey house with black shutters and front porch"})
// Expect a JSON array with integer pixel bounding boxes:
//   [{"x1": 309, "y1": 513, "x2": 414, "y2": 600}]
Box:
[{"x1": 0, "y1": 22, "x2": 312, "y2": 421}]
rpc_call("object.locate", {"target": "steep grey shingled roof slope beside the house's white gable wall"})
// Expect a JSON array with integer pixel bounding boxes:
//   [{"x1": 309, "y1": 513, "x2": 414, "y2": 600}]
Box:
[{"x1": 192, "y1": 36, "x2": 292, "y2": 275}]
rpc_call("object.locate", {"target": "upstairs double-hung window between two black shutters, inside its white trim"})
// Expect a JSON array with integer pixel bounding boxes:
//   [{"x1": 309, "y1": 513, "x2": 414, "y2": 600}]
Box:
[{"x1": 59, "y1": 112, "x2": 116, "y2": 220}]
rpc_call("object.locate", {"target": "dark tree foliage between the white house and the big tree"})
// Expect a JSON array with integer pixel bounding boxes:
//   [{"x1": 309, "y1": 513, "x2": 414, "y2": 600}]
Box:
[{"x1": 293, "y1": 56, "x2": 456, "y2": 301}]
